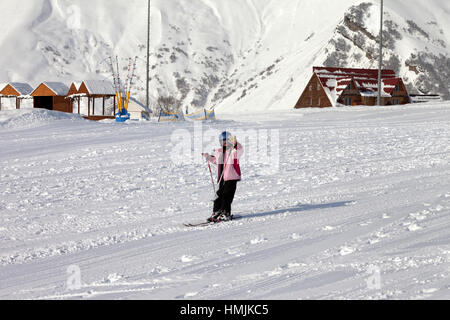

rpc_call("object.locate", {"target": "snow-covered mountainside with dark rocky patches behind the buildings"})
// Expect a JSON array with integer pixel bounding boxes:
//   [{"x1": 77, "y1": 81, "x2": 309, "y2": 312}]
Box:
[{"x1": 0, "y1": 0, "x2": 450, "y2": 113}]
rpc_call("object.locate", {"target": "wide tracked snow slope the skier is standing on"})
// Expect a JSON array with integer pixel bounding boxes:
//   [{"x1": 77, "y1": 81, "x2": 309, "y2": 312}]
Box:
[{"x1": 0, "y1": 103, "x2": 450, "y2": 299}]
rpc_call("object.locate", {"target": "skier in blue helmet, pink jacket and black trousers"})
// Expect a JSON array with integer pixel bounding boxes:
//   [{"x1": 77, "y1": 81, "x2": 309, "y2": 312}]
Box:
[{"x1": 202, "y1": 132, "x2": 244, "y2": 222}]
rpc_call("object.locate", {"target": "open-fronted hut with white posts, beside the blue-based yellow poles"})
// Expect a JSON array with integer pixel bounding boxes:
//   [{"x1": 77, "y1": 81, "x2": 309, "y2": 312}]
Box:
[{"x1": 67, "y1": 80, "x2": 117, "y2": 120}]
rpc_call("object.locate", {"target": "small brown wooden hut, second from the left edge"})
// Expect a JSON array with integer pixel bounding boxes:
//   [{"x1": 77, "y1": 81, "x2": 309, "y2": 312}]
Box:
[{"x1": 31, "y1": 82, "x2": 72, "y2": 113}]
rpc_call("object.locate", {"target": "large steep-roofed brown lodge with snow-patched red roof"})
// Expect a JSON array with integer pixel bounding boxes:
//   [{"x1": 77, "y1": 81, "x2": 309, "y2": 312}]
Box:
[{"x1": 295, "y1": 67, "x2": 411, "y2": 109}]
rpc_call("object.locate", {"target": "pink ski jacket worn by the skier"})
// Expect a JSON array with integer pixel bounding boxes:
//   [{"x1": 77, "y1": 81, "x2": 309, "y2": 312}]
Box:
[{"x1": 207, "y1": 143, "x2": 244, "y2": 182}]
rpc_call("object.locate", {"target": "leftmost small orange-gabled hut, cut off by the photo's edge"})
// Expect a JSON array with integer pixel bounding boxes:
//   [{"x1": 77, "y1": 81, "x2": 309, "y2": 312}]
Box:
[{"x1": 0, "y1": 82, "x2": 33, "y2": 110}]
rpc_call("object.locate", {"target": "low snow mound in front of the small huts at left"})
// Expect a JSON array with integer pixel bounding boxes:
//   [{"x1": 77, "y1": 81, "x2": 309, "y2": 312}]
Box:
[{"x1": 0, "y1": 109, "x2": 86, "y2": 129}]
